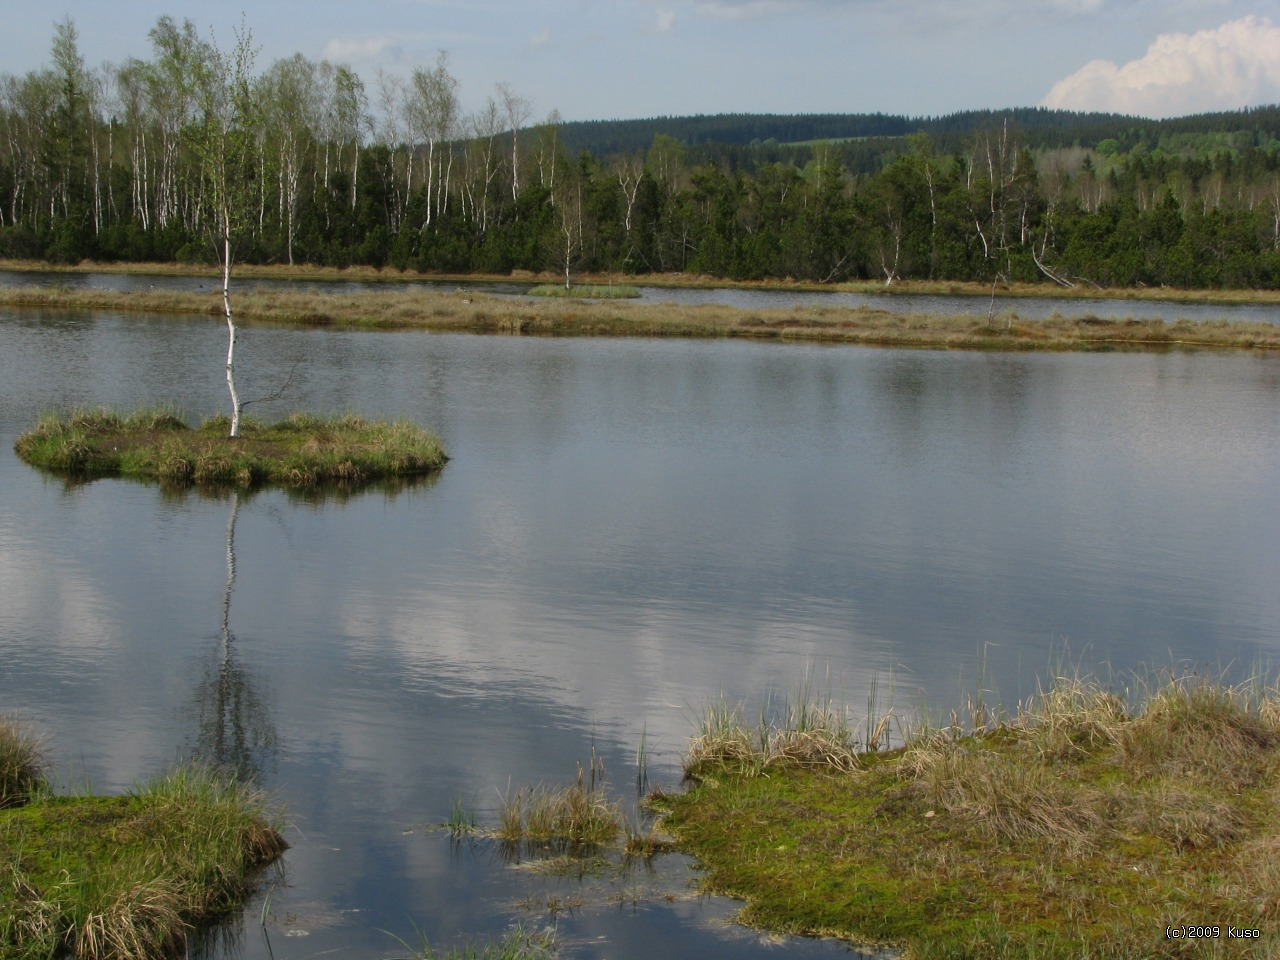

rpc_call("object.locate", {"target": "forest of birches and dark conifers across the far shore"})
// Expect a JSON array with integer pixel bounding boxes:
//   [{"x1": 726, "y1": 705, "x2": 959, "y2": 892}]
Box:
[{"x1": 0, "y1": 17, "x2": 1280, "y2": 288}]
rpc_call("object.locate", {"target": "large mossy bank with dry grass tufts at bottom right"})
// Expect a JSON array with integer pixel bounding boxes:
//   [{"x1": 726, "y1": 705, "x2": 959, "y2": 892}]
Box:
[{"x1": 659, "y1": 676, "x2": 1280, "y2": 960}]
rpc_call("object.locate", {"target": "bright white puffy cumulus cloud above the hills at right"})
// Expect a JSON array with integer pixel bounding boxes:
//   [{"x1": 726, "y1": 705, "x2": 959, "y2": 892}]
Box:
[{"x1": 1042, "y1": 17, "x2": 1280, "y2": 116}]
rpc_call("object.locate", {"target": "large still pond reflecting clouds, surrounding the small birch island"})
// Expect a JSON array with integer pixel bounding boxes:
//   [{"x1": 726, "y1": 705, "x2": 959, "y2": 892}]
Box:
[{"x1": 0, "y1": 311, "x2": 1280, "y2": 960}]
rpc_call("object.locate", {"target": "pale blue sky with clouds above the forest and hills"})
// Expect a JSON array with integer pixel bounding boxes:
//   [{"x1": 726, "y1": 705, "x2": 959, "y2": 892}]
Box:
[{"x1": 0, "y1": 0, "x2": 1280, "y2": 120}]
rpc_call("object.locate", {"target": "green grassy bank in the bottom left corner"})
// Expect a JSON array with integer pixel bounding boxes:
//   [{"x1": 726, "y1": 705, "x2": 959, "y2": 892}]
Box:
[{"x1": 0, "y1": 721, "x2": 285, "y2": 960}]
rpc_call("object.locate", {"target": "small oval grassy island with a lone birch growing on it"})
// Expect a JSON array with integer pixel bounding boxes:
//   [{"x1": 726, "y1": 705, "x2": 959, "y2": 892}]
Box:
[{"x1": 14, "y1": 410, "x2": 447, "y2": 488}]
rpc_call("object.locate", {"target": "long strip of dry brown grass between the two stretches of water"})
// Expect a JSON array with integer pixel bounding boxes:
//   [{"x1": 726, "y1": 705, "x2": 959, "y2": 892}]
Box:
[{"x1": 0, "y1": 285, "x2": 1280, "y2": 351}]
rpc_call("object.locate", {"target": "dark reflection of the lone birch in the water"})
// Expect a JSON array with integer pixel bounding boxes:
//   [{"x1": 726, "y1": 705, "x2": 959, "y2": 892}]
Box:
[{"x1": 193, "y1": 490, "x2": 276, "y2": 781}]
